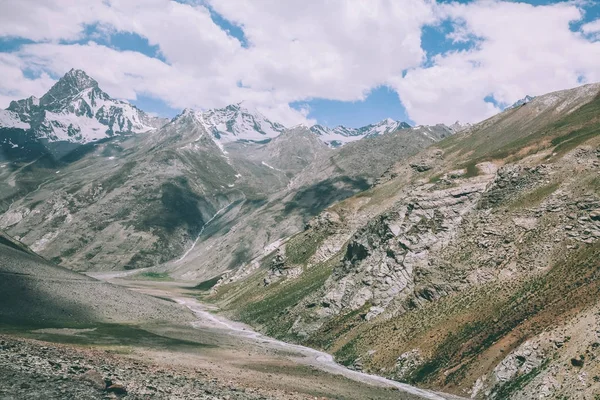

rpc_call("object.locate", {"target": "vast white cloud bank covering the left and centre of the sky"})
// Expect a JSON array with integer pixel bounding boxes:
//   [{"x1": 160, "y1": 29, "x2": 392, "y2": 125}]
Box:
[{"x1": 0, "y1": 0, "x2": 432, "y2": 123}]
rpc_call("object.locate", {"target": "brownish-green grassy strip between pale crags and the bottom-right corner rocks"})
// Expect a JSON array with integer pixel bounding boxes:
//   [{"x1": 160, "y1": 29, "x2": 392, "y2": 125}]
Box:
[{"x1": 411, "y1": 243, "x2": 600, "y2": 384}]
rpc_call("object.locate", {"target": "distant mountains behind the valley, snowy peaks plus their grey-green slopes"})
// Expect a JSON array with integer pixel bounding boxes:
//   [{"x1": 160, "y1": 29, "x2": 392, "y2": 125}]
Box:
[{"x1": 0, "y1": 70, "x2": 452, "y2": 269}]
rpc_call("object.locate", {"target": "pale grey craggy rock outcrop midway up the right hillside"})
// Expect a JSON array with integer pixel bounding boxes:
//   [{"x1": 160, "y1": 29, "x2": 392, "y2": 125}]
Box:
[{"x1": 316, "y1": 181, "x2": 487, "y2": 321}]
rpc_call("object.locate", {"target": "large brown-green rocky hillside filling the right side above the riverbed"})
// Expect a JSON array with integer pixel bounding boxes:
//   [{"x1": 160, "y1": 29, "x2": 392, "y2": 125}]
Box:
[{"x1": 205, "y1": 85, "x2": 600, "y2": 399}]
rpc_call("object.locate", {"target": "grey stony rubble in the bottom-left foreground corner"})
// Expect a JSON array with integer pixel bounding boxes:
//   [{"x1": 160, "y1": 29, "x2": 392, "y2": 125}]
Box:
[{"x1": 0, "y1": 335, "x2": 266, "y2": 400}]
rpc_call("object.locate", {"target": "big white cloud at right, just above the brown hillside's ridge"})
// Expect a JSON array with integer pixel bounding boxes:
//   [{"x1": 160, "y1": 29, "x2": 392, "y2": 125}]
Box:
[{"x1": 391, "y1": 1, "x2": 600, "y2": 124}]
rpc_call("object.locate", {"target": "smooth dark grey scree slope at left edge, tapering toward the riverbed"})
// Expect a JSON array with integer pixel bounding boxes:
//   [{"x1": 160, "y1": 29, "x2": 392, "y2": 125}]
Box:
[{"x1": 0, "y1": 232, "x2": 193, "y2": 328}]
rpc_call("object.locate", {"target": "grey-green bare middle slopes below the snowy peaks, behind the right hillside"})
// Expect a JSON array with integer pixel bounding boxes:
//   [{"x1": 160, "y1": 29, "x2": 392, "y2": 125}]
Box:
[{"x1": 0, "y1": 110, "x2": 449, "y2": 277}]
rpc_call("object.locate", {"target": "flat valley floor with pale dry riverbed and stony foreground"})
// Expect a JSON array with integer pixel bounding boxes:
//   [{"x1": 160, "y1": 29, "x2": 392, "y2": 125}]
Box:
[{"x1": 0, "y1": 276, "x2": 462, "y2": 399}]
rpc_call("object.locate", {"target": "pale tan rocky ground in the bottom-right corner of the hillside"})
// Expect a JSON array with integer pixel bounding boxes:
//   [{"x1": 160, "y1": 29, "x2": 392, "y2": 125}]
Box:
[{"x1": 470, "y1": 305, "x2": 600, "y2": 400}]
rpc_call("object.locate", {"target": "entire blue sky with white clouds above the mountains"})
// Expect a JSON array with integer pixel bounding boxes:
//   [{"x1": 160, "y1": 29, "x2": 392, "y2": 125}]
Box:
[{"x1": 0, "y1": 0, "x2": 600, "y2": 127}]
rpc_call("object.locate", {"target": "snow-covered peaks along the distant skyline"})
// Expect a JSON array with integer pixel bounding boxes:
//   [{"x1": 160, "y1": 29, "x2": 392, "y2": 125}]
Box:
[{"x1": 0, "y1": 69, "x2": 460, "y2": 153}]
